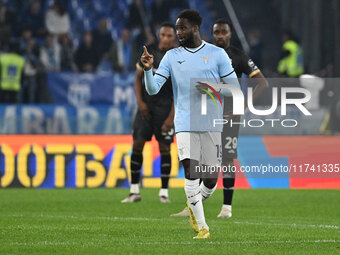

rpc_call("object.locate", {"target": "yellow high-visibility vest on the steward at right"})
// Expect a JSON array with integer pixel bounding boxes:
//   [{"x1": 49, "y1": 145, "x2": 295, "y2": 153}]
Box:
[{"x1": 277, "y1": 40, "x2": 304, "y2": 77}]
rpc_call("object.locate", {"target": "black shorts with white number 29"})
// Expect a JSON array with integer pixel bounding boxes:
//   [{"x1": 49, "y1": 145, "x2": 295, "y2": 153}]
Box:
[{"x1": 222, "y1": 116, "x2": 241, "y2": 163}]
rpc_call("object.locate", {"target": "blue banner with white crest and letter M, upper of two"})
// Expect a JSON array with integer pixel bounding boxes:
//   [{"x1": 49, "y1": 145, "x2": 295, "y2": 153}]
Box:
[{"x1": 47, "y1": 72, "x2": 135, "y2": 109}]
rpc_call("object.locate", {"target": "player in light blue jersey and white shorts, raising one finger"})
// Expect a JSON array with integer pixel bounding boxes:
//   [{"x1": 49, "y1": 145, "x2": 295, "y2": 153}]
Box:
[{"x1": 141, "y1": 10, "x2": 240, "y2": 239}]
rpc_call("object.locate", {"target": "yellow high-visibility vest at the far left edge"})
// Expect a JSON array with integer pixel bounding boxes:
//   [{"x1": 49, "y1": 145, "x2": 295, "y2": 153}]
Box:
[{"x1": 0, "y1": 53, "x2": 25, "y2": 91}]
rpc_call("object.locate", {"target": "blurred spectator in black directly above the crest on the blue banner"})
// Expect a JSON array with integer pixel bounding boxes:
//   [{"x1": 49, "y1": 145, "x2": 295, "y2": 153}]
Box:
[{"x1": 75, "y1": 31, "x2": 100, "y2": 72}]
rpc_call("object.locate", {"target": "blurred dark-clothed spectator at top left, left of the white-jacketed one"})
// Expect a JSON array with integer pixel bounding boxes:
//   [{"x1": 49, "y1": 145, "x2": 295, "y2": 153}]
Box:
[{"x1": 21, "y1": 0, "x2": 46, "y2": 38}]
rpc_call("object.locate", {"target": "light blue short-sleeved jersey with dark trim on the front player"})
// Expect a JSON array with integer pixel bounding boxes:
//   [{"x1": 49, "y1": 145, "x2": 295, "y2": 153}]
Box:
[{"x1": 144, "y1": 41, "x2": 240, "y2": 133}]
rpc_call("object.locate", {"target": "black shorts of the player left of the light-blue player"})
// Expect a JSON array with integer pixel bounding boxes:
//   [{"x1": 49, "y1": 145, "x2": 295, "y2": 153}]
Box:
[{"x1": 133, "y1": 104, "x2": 175, "y2": 144}]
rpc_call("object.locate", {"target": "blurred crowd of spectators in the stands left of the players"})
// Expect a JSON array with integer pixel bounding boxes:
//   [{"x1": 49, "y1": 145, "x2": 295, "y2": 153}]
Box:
[{"x1": 0, "y1": 0, "x2": 188, "y2": 103}]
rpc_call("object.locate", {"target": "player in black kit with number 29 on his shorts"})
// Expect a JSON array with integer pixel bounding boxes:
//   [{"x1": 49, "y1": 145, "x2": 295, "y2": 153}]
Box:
[{"x1": 212, "y1": 19, "x2": 269, "y2": 218}]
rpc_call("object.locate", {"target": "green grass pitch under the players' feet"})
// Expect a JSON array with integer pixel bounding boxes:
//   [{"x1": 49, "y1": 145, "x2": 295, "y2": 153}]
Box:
[{"x1": 0, "y1": 189, "x2": 340, "y2": 255}]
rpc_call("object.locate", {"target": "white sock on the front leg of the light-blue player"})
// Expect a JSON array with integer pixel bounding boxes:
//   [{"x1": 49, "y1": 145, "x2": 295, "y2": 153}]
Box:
[{"x1": 184, "y1": 179, "x2": 209, "y2": 230}]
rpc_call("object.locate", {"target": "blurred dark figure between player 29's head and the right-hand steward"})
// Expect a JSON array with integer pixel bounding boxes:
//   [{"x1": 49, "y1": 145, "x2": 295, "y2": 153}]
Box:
[{"x1": 248, "y1": 28, "x2": 263, "y2": 69}]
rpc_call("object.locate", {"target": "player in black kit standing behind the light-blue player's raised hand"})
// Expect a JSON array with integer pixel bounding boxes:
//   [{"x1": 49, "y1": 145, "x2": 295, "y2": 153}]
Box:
[{"x1": 122, "y1": 22, "x2": 176, "y2": 203}]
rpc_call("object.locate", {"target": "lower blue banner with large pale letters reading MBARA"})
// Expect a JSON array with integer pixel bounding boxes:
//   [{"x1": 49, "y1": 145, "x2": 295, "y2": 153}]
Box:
[{"x1": 0, "y1": 104, "x2": 134, "y2": 134}]
